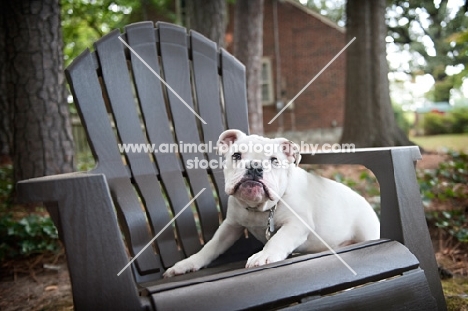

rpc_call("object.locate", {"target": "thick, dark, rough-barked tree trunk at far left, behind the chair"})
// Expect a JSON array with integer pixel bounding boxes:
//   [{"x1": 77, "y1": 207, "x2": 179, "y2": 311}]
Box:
[{"x1": 0, "y1": 0, "x2": 73, "y2": 181}]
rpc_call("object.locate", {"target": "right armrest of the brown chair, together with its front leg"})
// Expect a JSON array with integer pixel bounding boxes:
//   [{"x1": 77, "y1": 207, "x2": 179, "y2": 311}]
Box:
[{"x1": 301, "y1": 146, "x2": 445, "y2": 306}]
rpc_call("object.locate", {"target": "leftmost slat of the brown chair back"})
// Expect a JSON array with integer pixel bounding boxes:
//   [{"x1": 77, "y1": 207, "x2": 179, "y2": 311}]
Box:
[{"x1": 67, "y1": 51, "x2": 161, "y2": 273}]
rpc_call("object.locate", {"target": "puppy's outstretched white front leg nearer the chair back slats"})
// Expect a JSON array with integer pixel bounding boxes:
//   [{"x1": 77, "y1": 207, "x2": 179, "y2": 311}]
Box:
[{"x1": 163, "y1": 220, "x2": 244, "y2": 278}]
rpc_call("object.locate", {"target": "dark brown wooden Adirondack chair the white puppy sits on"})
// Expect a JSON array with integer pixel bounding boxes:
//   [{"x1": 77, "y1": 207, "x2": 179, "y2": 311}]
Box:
[{"x1": 17, "y1": 22, "x2": 445, "y2": 310}]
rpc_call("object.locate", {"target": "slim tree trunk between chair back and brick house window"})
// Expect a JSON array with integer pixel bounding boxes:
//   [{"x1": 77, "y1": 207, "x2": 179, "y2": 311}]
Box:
[{"x1": 234, "y1": 0, "x2": 263, "y2": 135}]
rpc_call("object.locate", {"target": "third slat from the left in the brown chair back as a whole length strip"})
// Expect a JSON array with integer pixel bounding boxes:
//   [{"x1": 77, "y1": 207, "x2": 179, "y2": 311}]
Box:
[{"x1": 122, "y1": 23, "x2": 205, "y2": 260}]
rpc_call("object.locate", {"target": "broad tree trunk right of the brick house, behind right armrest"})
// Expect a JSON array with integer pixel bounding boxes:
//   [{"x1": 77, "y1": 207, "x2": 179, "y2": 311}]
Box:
[{"x1": 341, "y1": 0, "x2": 412, "y2": 147}]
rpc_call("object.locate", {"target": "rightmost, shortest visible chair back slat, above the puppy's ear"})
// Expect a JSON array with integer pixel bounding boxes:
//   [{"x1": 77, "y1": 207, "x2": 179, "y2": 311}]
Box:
[{"x1": 221, "y1": 49, "x2": 249, "y2": 133}]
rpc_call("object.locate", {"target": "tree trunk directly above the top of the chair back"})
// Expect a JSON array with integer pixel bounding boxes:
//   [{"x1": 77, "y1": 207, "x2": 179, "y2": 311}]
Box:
[{"x1": 185, "y1": 0, "x2": 226, "y2": 47}]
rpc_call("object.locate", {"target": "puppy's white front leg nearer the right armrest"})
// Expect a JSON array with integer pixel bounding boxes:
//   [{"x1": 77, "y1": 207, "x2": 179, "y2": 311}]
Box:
[{"x1": 245, "y1": 223, "x2": 309, "y2": 268}]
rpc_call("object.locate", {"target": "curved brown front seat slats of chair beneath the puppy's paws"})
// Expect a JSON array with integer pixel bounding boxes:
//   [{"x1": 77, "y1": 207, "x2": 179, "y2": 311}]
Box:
[{"x1": 147, "y1": 241, "x2": 427, "y2": 310}]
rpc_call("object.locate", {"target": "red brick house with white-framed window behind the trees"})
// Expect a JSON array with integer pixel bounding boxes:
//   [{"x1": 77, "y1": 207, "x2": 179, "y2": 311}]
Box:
[{"x1": 226, "y1": 0, "x2": 346, "y2": 142}]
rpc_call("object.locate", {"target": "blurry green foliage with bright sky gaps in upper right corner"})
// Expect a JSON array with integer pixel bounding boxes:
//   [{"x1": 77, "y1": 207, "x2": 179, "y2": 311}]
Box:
[{"x1": 387, "y1": 0, "x2": 468, "y2": 101}]
